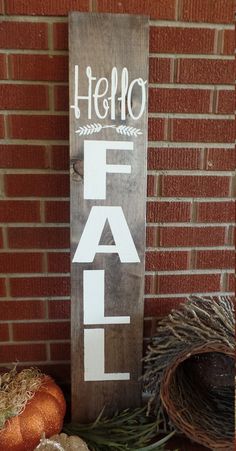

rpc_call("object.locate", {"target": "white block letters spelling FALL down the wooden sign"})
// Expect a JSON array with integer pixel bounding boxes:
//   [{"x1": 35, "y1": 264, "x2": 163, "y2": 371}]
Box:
[{"x1": 73, "y1": 140, "x2": 140, "y2": 381}]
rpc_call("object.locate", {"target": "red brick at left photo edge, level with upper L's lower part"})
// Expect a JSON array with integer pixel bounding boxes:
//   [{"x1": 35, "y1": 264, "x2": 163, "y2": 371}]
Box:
[{"x1": 0, "y1": 300, "x2": 46, "y2": 321}]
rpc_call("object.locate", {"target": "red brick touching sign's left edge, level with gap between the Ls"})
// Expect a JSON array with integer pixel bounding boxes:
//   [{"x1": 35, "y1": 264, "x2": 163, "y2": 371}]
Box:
[{"x1": 13, "y1": 322, "x2": 70, "y2": 341}]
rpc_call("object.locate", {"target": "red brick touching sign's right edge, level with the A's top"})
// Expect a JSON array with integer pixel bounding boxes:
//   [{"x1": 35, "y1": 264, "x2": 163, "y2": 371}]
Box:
[{"x1": 147, "y1": 202, "x2": 191, "y2": 222}]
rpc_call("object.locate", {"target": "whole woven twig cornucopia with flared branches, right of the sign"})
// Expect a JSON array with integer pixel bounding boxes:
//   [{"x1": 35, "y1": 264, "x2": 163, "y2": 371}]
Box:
[{"x1": 143, "y1": 296, "x2": 235, "y2": 450}]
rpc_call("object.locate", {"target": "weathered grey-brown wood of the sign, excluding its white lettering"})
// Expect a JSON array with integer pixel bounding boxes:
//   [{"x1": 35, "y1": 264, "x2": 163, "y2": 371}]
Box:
[{"x1": 69, "y1": 12, "x2": 148, "y2": 421}]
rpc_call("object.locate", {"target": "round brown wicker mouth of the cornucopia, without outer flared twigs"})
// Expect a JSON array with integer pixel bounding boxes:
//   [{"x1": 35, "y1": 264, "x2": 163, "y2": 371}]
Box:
[{"x1": 160, "y1": 346, "x2": 234, "y2": 450}]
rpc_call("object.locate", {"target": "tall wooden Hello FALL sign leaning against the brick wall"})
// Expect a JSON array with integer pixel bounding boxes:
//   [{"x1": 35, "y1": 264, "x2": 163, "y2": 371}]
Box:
[{"x1": 69, "y1": 12, "x2": 148, "y2": 422}]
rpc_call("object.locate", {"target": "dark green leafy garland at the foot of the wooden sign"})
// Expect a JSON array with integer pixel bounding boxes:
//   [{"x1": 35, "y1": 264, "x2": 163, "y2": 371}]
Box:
[{"x1": 63, "y1": 406, "x2": 175, "y2": 451}]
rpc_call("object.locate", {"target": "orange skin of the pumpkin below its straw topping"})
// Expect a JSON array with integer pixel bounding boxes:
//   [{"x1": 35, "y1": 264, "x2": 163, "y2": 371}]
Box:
[{"x1": 0, "y1": 376, "x2": 66, "y2": 451}]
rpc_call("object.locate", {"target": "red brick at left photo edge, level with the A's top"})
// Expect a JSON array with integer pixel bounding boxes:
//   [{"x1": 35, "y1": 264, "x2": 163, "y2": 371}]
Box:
[{"x1": 0, "y1": 200, "x2": 40, "y2": 223}]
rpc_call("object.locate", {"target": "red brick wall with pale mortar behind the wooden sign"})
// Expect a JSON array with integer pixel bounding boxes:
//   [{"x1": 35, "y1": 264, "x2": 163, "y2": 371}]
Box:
[{"x1": 0, "y1": 0, "x2": 234, "y2": 381}]
